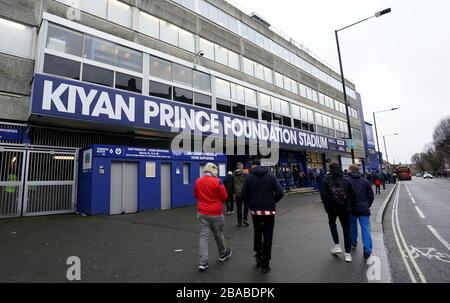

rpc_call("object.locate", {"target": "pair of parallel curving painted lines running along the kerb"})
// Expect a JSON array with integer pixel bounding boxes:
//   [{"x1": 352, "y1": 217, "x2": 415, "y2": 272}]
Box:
[{"x1": 392, "y1": 183, "x2": 427, "y2": 283}]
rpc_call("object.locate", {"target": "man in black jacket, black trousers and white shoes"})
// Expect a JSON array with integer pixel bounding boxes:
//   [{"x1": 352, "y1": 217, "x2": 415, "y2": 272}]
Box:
[{"x1": 320, "y1": 163, "x2": 356, "y2": 262}]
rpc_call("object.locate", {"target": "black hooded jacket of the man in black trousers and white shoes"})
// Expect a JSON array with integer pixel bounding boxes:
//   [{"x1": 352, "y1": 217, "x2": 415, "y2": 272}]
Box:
[{"x1": 320, "y1": 167, "x2": 356, "y2": 213}]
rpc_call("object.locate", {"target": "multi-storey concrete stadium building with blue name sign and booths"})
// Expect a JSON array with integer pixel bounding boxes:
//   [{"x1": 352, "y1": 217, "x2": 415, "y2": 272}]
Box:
[{"x1": 0, "y1": 0, "x2": 365, "y2": 217}]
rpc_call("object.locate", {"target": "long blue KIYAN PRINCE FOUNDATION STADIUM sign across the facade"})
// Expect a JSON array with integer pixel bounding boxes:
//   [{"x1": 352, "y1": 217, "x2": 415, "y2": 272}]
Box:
[{"x1": 32, "y1": 74, "x2": 345, "y2": 151}]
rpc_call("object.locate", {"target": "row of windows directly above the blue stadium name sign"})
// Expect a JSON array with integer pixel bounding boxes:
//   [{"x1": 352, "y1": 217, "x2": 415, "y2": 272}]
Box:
[{"x1": 44, "y1": 19, "x2": 358, "y2": 141}]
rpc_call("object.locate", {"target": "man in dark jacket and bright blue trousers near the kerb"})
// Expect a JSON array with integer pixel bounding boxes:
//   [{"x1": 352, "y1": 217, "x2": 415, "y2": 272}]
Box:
[{"x1": 348, "y1": 165, "x2": 374, "y2": 259}]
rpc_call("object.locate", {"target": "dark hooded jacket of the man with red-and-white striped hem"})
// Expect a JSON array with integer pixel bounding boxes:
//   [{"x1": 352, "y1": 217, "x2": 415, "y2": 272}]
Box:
[{"x1": 242, "y1": 166, "x2": 283, "y2": 212}]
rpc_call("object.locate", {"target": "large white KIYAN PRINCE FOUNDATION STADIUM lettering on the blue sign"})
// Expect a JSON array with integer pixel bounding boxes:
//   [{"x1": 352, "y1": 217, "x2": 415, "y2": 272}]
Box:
[{"x1": 39, "y1": 76, "x2": 339, "y2": 149}]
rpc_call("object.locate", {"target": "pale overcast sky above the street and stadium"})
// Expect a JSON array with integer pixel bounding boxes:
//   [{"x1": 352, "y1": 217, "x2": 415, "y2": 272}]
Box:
[{"x1": 228, "y1": 0, "x2": 450, "y2": 163}]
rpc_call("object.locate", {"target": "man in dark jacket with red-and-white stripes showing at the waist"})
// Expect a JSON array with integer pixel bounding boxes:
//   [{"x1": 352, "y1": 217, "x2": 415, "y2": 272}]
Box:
[{"x1": 242, "y1": 159, "x2": 283, "y2": 273}]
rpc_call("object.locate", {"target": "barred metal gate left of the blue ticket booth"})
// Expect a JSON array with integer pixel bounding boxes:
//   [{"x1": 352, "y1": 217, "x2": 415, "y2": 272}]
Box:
[{"x1": 0, "y1": 146, "x2": 77, "y2": 218}]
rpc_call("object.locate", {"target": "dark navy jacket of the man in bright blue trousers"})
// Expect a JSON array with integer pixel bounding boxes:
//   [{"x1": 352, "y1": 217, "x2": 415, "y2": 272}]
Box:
[{"x1": 348, "y1": 173, "x2": 374, "y2": 216}]
